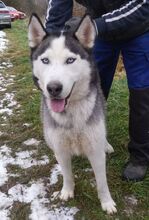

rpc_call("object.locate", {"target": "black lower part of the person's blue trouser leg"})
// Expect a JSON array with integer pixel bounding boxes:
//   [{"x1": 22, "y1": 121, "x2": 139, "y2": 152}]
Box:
[{"x1": 128, "y1": 89, "x2": 149, "y2": 164}]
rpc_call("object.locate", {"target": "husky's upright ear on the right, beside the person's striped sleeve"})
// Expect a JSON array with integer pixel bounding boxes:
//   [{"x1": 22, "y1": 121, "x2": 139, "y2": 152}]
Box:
[{"x1": 75, "y1": 15, "x2": 96, "y2": 49}]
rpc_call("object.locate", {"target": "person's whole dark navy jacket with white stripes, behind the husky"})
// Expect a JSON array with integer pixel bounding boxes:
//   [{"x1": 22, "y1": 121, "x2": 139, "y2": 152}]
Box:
[{"x1": 46, "y1": 0, "x2": 149, "y2": 41}]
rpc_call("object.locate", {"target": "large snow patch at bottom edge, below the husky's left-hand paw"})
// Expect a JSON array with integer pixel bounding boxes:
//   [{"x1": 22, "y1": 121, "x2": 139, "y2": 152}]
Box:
[{"x1": 8, "y1": 181, "x2": 79, "y2": 220}]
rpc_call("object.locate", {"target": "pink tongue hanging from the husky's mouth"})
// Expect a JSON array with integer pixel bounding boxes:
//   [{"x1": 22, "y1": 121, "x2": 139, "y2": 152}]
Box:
[{"x1": 51, "y1": 99, "x2": 65, "y2": 112}]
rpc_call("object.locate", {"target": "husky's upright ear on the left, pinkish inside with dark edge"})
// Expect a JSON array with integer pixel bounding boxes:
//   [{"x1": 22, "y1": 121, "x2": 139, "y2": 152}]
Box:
[{"x1": 28, "y1": 14, "x2": 47, "y2": 48}]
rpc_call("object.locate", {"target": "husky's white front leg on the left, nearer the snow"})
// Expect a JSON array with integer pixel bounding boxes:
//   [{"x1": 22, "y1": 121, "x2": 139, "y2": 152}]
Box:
[{"x1": 56, "y1": 150, "x2": 74, "y2": 201}]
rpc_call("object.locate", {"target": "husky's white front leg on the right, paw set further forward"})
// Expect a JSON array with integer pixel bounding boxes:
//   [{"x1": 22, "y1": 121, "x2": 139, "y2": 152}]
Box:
[{"x1": 88, "y1": 149, "x2": 117, "y2": 214}]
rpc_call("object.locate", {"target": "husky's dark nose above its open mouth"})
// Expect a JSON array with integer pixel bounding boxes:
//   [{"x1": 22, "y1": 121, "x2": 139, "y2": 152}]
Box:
[{"x1": 47, "y1": 81, "x2": 63, "y2": 97}]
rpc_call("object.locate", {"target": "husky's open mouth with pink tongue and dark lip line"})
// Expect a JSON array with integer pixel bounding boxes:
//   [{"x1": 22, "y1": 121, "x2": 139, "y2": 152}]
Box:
[{"x1": 50, "y1": 83, "x2": 75, "y2": 112}]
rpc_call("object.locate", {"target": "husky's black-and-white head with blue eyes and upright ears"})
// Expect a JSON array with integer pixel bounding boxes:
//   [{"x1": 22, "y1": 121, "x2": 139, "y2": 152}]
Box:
[{"x1": 28, "y1": 14, "x2": 96, "y2": 112}]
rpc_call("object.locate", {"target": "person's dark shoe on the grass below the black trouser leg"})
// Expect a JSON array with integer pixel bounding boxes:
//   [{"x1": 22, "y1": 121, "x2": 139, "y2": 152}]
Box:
[{"x1": 122, "y1": 161, "x2": 148, "y2": 181}]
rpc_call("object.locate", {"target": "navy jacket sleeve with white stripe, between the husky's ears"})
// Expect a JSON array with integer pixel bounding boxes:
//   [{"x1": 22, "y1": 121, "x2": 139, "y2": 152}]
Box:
[{"x1": 45, "y1": 0, "x2": 73, "y2": 32}]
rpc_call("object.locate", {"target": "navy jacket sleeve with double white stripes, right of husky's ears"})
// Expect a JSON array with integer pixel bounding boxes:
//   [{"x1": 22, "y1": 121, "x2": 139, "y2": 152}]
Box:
[{"x1": 95, "y1": 0, "x2": 149, "y2": 40}]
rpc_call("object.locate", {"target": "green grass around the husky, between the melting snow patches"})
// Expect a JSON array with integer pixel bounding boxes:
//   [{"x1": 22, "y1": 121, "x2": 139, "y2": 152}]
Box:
[{"x1": 0, "y1": 21, "x2": 149, "y2": 220}]
